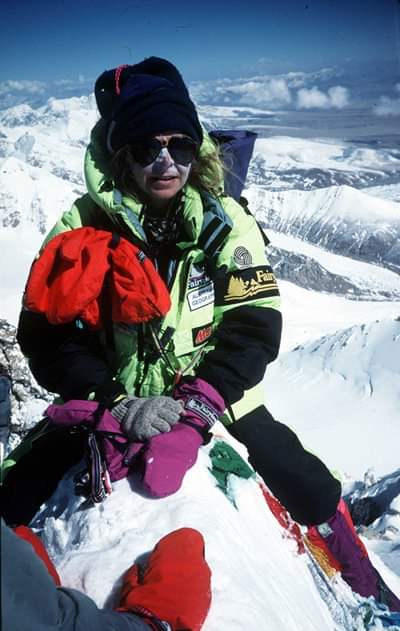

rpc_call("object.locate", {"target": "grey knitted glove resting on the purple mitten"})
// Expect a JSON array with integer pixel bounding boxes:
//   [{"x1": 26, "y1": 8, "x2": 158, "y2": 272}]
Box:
[{"x1": 111, "y1": 396, "x2": 183, "y2": 441}]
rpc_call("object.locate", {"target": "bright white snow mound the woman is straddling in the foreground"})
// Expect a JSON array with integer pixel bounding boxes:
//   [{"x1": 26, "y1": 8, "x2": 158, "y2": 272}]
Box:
[{"x1": 32, "y1": 439, "x2": 400, "y2": 631}]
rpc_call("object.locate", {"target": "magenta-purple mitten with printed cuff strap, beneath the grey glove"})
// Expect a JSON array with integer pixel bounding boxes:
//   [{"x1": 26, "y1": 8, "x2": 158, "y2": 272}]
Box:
[{"x1": 143, "y1": 378, "x2": 225, "y2": 497}]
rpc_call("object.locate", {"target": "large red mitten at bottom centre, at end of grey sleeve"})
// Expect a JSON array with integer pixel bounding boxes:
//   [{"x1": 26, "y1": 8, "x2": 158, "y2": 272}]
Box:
[{"x1": 119, "y1": 528, "x2": 211, "y2": 631}]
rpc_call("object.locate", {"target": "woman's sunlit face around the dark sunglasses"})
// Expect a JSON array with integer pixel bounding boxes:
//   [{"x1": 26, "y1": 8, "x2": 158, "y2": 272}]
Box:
[{"x1": 133, "y1": 134, "x2": 191, "y2": 208}]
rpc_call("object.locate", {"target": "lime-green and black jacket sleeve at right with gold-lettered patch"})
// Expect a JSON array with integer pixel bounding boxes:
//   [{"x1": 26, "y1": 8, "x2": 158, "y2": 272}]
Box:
[{"x1": 196, "y1": 198, "x2": 282, "y2": 406}]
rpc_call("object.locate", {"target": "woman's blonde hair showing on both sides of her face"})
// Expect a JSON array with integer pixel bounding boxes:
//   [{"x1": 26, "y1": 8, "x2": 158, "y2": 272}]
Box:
[{"x1": 111, "y1": 135, "x2": 224, "y2": 201}]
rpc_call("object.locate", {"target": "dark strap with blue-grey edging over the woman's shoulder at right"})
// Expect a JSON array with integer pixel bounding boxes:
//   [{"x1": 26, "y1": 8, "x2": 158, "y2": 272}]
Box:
[{"x1": 198, "y1": 191, "x2": 233, "y2": 261}]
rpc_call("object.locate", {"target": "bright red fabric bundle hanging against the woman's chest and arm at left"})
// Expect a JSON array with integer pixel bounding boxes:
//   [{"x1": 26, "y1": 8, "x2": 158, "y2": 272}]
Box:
[{"x1": 24, "y1": 227, "x2": 171, "y2": 329}]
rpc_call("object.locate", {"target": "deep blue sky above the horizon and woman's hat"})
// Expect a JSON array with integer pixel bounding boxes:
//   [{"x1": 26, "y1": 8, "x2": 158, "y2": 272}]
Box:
[{"x1": 0, "y1": 0, "x2": 400, "y2": 113}]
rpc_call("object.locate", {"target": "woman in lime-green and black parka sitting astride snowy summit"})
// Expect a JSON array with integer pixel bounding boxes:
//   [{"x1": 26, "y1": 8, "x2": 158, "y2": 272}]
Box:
[{"x1": 11, "y1": 57, "x2": 398, "y2": 606}]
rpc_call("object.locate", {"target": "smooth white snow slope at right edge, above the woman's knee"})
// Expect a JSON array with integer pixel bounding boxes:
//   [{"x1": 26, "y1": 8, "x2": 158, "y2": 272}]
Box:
[{"x1": 265, "y1": 320, "x2": 400, "y2": 479}]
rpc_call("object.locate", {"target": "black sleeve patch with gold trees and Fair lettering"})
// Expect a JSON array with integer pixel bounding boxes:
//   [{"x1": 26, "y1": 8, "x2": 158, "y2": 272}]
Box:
[{"x1": 215, "y1": 265, "x2": 279, "y2": 305}]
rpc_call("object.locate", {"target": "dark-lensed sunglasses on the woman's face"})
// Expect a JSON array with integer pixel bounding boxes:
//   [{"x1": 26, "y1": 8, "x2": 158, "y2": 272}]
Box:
[{"x1": 130, "y1": 136, "x2": 199, "y2": 167}]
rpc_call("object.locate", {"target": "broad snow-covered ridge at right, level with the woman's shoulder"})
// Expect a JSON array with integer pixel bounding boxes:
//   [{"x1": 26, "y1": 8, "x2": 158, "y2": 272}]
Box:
[{"x1": 246, "y1": 186, "x2": 400, "y2": 270}]
